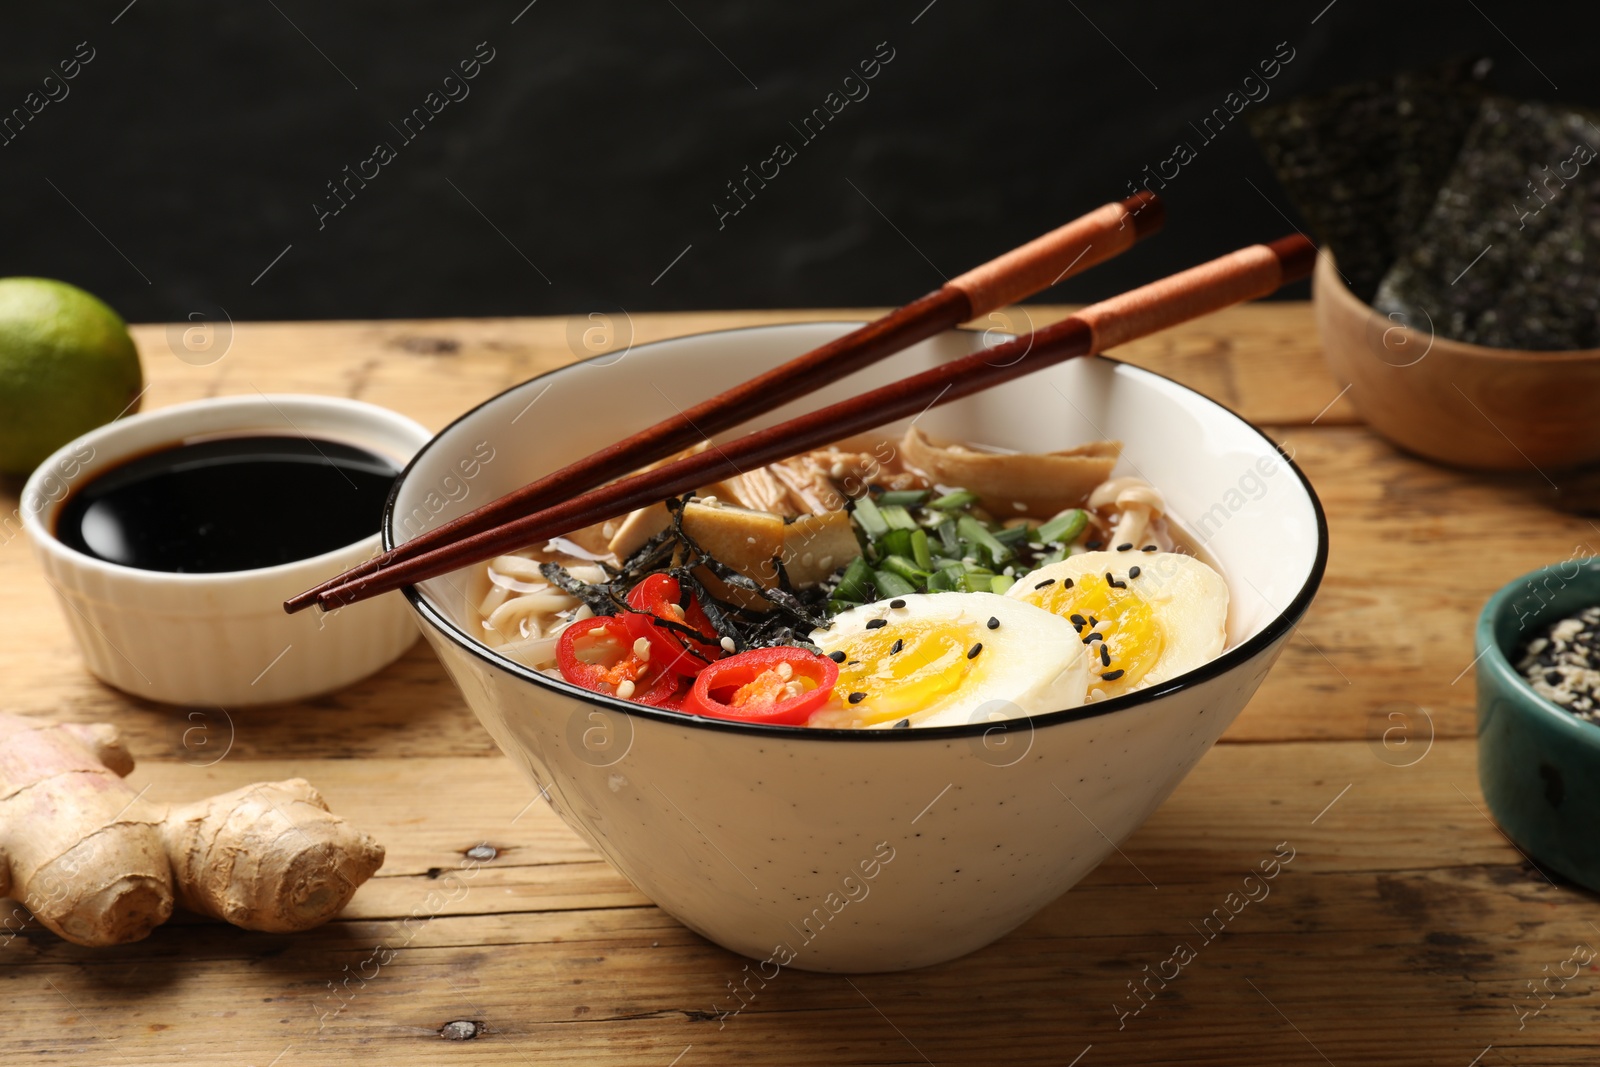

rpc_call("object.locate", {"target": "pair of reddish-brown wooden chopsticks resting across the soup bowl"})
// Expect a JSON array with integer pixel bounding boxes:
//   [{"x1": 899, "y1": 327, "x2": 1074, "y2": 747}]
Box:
[{"x1": 285, "y1": 194, "x2": 1317, "y2": 611}]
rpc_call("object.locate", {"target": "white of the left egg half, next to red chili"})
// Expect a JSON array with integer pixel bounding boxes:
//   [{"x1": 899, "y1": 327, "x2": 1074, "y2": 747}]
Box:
[{"x1": 811, "y1": 592, "x2": 1090, "y2": 726}]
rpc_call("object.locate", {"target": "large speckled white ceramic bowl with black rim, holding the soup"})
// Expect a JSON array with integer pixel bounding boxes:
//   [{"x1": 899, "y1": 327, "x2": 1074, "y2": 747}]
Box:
[{"x1": 384, "y1": 323, "x2": 1328, "y2": 972}]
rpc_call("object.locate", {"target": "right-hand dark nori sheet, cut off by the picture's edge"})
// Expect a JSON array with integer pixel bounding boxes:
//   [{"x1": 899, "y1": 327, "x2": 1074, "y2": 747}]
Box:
[{"x1": 1373, "y1": 96, "x2": 1600, "y2": 349}]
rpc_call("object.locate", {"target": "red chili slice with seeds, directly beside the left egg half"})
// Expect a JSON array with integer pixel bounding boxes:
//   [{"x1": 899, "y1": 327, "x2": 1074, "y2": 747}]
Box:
[{"x1": 683, "y1": 646, "x2": 838, "y2": 726}]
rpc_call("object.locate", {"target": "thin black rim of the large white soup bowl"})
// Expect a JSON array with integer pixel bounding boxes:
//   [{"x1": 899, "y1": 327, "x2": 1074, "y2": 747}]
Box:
[{"x1": 382, "y1": 320, "x2": 1328, "y2": 744}]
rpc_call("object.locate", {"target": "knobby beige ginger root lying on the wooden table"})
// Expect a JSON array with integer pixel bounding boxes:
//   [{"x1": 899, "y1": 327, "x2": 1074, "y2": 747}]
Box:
[{"x1": 0, "y1": 715, "x2": 384, "y2": 945}]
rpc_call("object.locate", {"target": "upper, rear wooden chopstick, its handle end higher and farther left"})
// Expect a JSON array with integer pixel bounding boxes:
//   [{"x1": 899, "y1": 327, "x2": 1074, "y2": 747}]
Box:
[{"x1": 283, "y1": 192, "x2": 1165, "y2": 613}]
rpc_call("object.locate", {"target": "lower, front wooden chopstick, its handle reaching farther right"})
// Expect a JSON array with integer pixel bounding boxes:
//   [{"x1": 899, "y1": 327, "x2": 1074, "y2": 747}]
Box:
[{"x1": 317, "y1": 234, "x2": 1317, "y2": 609}]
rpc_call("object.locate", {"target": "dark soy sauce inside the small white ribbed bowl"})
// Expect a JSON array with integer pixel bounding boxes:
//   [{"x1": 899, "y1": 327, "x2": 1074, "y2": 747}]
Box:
[{"x1": 56, "y1": 437, "x2": 398, "y2": 574}]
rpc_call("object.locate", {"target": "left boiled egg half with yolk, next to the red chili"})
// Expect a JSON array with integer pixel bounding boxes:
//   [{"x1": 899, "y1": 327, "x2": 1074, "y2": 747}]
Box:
[{"x1": 810, "y1": 592, "x2": 1090, "y2": 728}]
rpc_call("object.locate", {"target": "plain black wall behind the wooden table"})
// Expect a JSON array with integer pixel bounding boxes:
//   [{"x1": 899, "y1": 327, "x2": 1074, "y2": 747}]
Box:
[{"x1": 0, "y1": 0, "x2": 1600, "y2": 322}]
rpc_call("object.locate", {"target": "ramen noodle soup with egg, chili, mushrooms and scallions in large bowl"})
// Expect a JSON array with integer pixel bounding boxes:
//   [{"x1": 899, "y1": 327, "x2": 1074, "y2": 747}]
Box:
[{"x1": 467, "y1": 427, "x2": 1229, "y2": 729}]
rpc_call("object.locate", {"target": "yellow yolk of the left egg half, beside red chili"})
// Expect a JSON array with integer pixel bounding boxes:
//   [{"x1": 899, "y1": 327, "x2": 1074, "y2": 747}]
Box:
[{"x1": 834, "y1": 619, "x2": 982, "y2": 725}]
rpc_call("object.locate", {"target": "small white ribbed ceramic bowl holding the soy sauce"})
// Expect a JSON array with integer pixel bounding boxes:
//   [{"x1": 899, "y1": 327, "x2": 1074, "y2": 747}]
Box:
[{"x1": 22, "y1": 394, "x2": 429, "y2": 707}]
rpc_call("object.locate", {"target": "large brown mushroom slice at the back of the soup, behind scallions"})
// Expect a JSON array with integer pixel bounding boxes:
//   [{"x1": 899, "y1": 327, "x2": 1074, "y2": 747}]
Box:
[{"x1": 901, "y1": 427, "x2": 1122, "y2": 517}]
